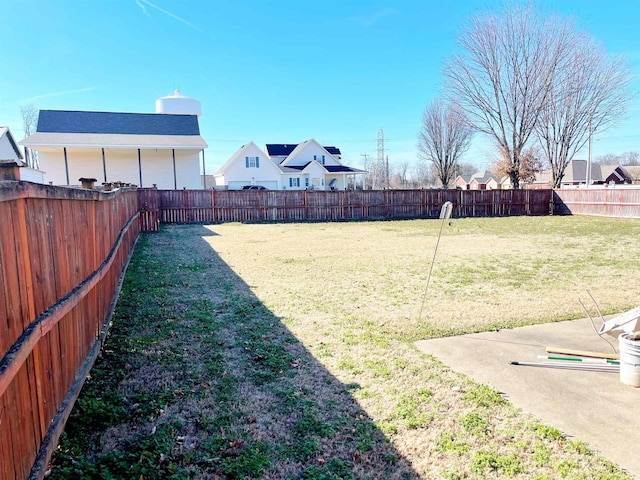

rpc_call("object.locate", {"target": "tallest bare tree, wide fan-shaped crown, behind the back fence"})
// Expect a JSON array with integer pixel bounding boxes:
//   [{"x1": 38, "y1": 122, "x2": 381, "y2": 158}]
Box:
[{"x1": 443, "y1": 4, "x2": 573, "y2": 188}]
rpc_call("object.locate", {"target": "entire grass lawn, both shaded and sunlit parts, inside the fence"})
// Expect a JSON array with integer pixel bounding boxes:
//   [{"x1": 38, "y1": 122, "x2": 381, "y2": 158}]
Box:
[{"x1": 49, "y1": 217, "x2": 640, "y2": 480}]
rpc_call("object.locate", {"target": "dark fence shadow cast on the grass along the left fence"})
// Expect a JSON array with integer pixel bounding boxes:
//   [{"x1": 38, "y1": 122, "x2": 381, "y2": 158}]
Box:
[{"x1": 49, "y1": 225, "x2": 417, "y2": 479}]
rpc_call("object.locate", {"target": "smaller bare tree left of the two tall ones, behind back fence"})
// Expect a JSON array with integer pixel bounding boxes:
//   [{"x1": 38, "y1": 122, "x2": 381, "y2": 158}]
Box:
[{"x1": 418, "y1": 99, "x2": 473, "y2": 188}]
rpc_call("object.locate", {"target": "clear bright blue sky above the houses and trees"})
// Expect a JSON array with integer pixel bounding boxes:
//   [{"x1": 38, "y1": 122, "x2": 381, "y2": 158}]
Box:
[{"x1": 0, "y1": 0, "x2": 640, "y2": 173}]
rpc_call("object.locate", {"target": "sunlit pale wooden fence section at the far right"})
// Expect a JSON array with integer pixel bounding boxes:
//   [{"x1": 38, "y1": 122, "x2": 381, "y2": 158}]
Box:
[{"x1": 553, "y1": 187, "x2": 640, "y2": 218}]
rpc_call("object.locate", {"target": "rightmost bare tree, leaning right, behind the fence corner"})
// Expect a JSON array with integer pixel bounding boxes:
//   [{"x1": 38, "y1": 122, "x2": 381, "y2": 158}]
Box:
[{"x1": 536, "y1": 34, "x2": 631, "y2": 188}]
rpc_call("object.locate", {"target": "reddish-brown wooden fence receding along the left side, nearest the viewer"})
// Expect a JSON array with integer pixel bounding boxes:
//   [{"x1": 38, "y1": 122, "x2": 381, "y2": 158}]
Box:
[{"x1": 0, "y1": 182, "x2": 140, "y2": 479}]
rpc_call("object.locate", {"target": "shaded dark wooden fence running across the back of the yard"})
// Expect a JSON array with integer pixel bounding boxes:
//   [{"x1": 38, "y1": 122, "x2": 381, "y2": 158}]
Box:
[{"x1": 138, "y1": 189, "x2": 552, "y2": 231}]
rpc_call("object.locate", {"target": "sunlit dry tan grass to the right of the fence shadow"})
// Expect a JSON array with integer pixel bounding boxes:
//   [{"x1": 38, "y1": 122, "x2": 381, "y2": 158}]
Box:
[{"x1": 196, "y1": 217, "x2": 640, "y2": 478}]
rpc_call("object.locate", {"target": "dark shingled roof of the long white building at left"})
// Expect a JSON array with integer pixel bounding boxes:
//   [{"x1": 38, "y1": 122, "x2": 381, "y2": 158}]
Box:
[{"x1": 36, "y1": 110, "x2": 200, "y2": 135}]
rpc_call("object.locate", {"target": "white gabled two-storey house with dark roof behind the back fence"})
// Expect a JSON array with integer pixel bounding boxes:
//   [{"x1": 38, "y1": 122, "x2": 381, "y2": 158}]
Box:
[{"x1": 215, "y1": 139, "x2": 366, "y2": 190}]
